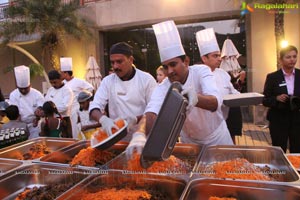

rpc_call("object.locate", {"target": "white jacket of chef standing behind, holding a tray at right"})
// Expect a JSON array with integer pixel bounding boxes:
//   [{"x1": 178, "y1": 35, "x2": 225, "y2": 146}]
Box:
[{"x1": 213, "y1": 68, "x2": 240, "y2": 119}]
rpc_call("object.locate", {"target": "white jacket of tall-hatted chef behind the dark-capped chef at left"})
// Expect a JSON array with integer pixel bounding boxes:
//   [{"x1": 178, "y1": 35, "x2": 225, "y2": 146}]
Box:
[{"x1": 63, "y1": 77, "x2": 94, "y2": 138}]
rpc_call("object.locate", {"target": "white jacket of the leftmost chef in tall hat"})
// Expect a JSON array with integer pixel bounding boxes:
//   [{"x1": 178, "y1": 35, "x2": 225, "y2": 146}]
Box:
[{"x1": 9, "y1": 87, "x2": 45, "y2": 139}]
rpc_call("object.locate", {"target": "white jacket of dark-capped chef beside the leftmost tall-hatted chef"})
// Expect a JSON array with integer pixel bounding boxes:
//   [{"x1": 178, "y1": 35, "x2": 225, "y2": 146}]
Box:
[{"x1": 45, "y1": 85, "x2": 73, "y2": 117}]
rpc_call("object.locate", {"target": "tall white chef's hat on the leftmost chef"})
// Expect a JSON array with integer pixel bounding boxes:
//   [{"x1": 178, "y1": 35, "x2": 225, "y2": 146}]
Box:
[{"x1": 14, "y1": 65, "x2": 30, "y2": 88}]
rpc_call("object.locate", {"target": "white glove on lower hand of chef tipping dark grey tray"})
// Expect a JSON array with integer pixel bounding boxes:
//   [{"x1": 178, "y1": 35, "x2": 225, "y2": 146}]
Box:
[{"x1": 126, "y1": 132, "x2": 146, "y2": 159}]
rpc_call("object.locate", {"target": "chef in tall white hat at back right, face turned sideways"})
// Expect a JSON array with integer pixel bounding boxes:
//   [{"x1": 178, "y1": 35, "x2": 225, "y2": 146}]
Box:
[{"x1": 196, "y1": 28, "x2": 243, "y2": 143}]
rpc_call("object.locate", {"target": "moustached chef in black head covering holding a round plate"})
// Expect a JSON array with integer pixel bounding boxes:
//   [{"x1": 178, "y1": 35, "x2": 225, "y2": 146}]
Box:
[{"x1": 89, "y1": 42, "x2": 157, "y2": 141}]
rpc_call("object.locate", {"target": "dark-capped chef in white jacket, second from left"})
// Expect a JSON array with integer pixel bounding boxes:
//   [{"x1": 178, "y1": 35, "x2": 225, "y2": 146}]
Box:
[{"x1": 45, "y1": 70, "x2": 73, "y2": 138}]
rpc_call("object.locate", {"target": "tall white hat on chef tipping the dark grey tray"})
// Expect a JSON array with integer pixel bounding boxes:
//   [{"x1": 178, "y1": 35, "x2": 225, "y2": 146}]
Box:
[{"x1": 152, "y1": 21, "x2": 185, "y2": 62}]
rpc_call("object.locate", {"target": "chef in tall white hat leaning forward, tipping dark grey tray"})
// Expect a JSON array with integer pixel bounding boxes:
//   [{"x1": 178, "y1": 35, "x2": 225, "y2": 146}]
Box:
[{"x1": 126, "y1": 21, "x2": 233, "y2": 156}]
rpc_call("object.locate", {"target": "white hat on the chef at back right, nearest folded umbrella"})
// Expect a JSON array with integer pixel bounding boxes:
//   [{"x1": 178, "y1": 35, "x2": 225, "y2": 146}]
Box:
[{"x1": 196, "y1": 28, "x2": 220, "y2": 56}]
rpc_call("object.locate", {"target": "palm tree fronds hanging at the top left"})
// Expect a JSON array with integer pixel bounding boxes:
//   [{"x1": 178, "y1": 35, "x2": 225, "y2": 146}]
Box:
[{"x1": 0, "y1": 0, "x2": 90, "y2": 48}]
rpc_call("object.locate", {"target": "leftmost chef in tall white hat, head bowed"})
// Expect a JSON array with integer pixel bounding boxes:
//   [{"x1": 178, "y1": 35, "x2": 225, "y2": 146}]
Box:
[{"x1": 9, "y1": 65, "x2": 44, "y2": 139}]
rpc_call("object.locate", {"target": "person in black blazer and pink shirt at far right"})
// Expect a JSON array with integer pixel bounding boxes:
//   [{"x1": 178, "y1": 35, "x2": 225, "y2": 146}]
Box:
[{"x1": 263, "y1": 45, "x2": 300, "y2": 153}]
